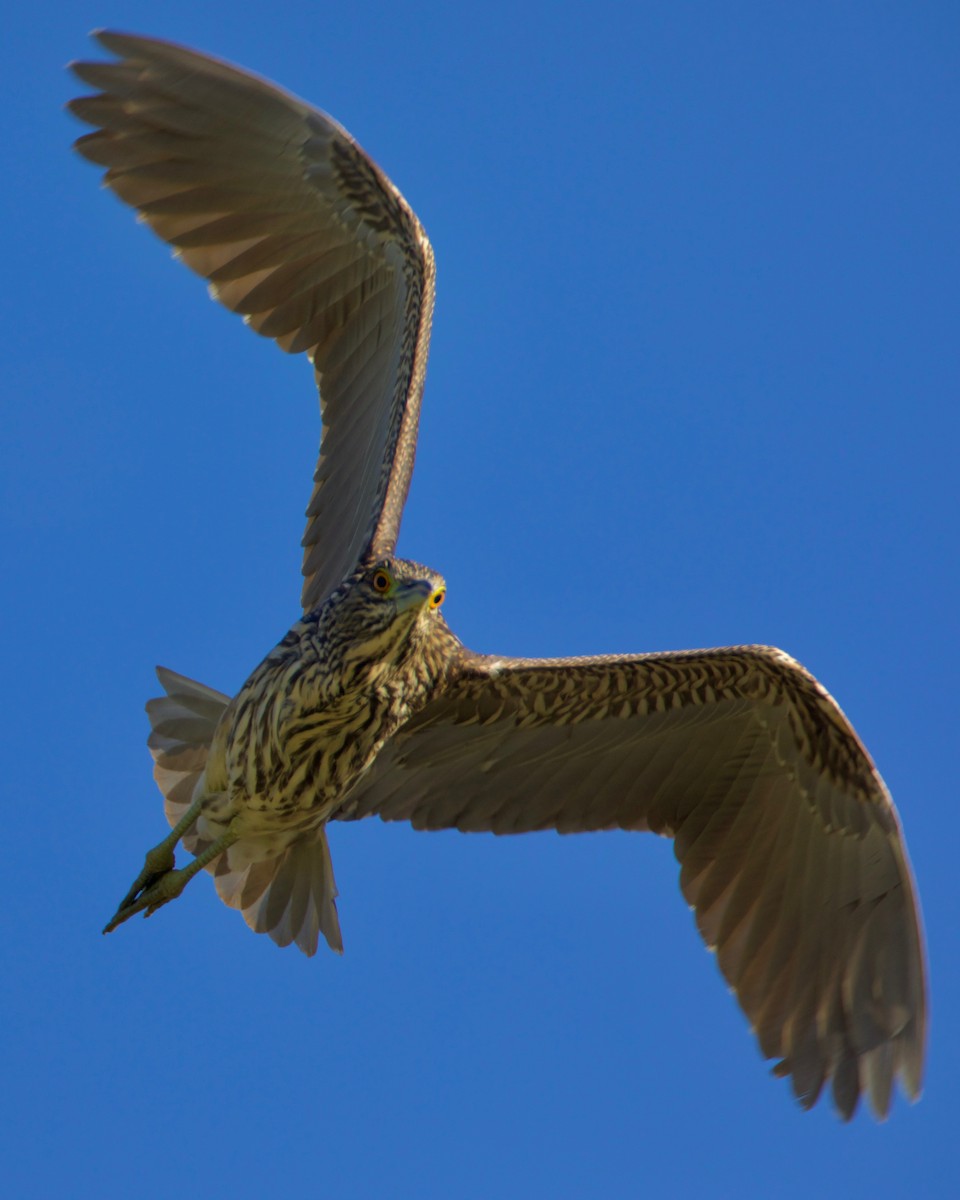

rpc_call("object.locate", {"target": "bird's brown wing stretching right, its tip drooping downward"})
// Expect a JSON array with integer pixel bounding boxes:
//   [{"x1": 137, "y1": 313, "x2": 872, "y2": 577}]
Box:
[{"x1": 340, "y1": 646, "x2": 925, "y2": 1117}]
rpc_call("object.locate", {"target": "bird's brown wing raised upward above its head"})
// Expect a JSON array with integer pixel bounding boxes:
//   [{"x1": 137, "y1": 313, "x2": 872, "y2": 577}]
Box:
[{"x1": 70, "y1": 32, "x2": 434, "y2": 610}]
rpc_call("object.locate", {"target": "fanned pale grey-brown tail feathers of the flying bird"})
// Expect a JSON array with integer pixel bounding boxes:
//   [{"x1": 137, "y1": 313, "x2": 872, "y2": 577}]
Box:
[{"x1": 146, "y1": 667, "x2": 343, "y2": 954}]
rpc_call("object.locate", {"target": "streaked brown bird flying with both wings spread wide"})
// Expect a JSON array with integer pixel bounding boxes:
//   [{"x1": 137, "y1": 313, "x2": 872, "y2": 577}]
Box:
[{"x1": 68, "y1": 31, "x2": 926, "y2": 1120}]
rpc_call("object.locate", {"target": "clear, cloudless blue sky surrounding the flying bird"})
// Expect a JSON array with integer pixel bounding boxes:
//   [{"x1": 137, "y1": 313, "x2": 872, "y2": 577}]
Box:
[{"x1": 0, "y1": 0, "x2": 960, "y2": 1200}]
